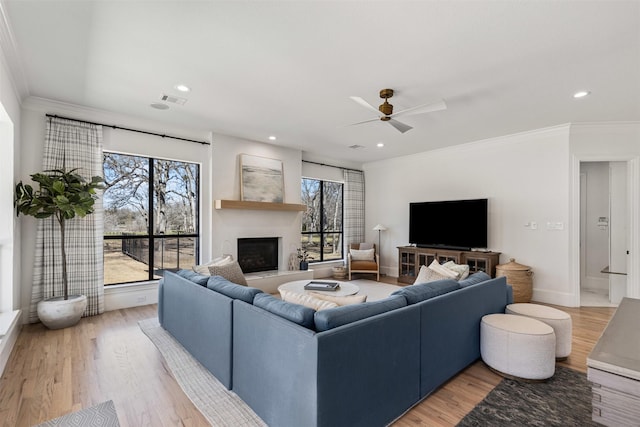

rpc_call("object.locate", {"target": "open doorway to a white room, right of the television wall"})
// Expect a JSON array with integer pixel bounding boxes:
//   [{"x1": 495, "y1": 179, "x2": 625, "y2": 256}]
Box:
[{"x1": 580, "y1": 161, "x2": 629, "y2": 307}]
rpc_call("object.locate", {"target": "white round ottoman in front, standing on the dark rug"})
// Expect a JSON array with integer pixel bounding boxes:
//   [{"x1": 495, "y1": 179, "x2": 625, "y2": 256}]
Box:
[{"x1": 480, "y1": 314, "x2": 556, "y2": 380}]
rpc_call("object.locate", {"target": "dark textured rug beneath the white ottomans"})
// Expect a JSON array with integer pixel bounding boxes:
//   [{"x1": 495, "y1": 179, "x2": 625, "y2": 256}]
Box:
[{"x1": 458, "y1": 366, "x2": 598, "y2": 427}]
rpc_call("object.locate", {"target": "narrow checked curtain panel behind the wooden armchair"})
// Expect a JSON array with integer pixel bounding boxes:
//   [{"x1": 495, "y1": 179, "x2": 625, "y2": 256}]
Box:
[{"x1": 344, "y1": 170, "x2": 364, "y2": 250}]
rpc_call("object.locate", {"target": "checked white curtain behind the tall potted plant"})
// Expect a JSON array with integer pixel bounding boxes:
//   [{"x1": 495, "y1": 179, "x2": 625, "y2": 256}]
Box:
[{"x1": 29, "y1": 117, "x2": 104, "y2": 323}]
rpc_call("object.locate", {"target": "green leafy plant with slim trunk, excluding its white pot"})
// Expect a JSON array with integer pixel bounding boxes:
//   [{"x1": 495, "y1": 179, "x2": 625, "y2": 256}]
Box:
[{"x1": 13, "y1": 169, "x2": 103, "y2": 300}]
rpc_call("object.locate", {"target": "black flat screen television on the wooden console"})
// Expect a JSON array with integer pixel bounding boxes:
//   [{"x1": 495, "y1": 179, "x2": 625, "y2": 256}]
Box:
[{"x1": 409, "y1": 199, "x2": 488, "y2": 250}]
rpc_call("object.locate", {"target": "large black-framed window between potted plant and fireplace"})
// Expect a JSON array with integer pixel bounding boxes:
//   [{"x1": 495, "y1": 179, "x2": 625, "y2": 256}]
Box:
[{"x1": 103, "y1": 153, "x2": 200, "y2": 285}]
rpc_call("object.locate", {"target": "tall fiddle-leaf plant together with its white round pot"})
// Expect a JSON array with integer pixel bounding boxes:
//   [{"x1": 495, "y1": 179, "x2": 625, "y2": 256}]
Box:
[{"x1": 13, "y1": 169, "x2": 103, "y2": 329}]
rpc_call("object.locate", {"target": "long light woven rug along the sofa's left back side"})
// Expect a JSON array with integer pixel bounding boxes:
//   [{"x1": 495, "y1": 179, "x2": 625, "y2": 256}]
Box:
[{"x1": 138, "y1": 318, "x2": 266, "y2": 427}]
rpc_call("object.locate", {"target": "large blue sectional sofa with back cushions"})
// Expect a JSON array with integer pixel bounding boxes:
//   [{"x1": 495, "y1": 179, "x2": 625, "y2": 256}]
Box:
[{"x1": 158, "y1": 270, "x2": 513, "y2": 427}]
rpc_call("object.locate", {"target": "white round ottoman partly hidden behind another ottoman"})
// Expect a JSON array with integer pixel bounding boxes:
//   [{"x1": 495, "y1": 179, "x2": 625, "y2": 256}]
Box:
[{"x1": 505, "y1": 303, "x2": 572, "y2": 360}]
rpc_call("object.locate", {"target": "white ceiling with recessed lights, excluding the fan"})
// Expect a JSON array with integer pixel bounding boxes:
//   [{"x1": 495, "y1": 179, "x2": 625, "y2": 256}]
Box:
[{"x1": 2, "y1": 0, "x2": 640, "y2": 163}]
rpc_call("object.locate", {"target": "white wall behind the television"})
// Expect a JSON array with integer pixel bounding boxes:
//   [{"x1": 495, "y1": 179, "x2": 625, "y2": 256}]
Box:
[{"x1": 364, "y1": 125, "x2": 572, "y2": 305}]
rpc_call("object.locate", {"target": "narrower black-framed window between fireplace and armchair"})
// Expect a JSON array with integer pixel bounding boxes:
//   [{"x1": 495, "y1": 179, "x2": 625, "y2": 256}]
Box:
[{"x1": 300, "y1": 178, "x2": 343, "y2": 262}]
